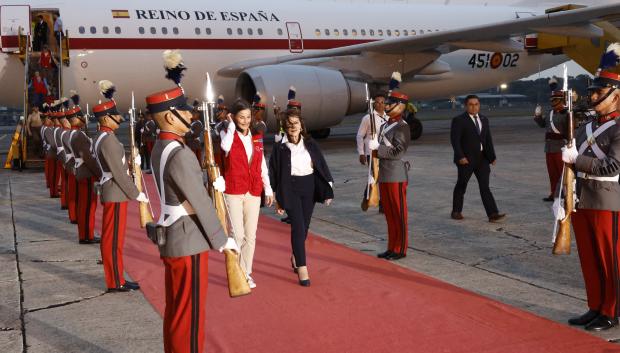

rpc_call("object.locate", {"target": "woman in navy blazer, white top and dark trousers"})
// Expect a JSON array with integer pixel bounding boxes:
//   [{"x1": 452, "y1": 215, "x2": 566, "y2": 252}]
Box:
[{"x1": 269, "y1": 109, "x2": 334, "y2": 287}]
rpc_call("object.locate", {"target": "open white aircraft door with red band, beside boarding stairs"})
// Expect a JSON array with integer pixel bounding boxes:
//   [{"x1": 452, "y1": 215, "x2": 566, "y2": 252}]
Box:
[{"x1": 0, "y1": 5, "x2": 30, "y2": 53}]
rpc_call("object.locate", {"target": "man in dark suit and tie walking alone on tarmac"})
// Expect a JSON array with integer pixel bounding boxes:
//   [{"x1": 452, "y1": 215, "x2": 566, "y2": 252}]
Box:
[{"x1": 450, "y1": 95, "x2": 506, "y2": 222}]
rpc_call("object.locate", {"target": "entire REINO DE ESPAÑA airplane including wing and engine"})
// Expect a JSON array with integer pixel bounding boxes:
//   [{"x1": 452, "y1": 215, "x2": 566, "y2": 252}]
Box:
[{"x1": 0, "y1": 0, "x2": 620, "y2": 137}]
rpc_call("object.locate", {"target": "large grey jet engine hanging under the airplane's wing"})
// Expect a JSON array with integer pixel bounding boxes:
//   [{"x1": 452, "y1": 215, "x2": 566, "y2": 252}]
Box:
[{"x1": 235, "y1": 65, "x2": 366, "y2": 137}]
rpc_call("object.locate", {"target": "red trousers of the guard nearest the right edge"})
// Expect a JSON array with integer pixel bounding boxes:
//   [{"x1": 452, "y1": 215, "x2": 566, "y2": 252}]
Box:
[{"x1": 571, "y1": 209, "x2": 620, "y2": 318}]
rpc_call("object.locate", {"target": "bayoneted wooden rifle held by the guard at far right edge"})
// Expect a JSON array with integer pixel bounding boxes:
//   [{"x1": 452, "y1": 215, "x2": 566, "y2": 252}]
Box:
[{"x1": 553, "y1": 64, "x2": 575, "y2": 255}]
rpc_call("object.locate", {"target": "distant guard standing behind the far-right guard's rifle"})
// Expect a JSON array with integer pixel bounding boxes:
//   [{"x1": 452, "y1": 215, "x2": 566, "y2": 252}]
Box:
[{"x1": 534, "y1": 77, "x2": 568, "y2": 201}]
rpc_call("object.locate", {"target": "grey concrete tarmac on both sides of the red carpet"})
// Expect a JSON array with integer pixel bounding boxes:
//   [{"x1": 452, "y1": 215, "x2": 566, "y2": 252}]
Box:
[{"x1": 0, "y1": 112, "x2": 620, "y2": 353}]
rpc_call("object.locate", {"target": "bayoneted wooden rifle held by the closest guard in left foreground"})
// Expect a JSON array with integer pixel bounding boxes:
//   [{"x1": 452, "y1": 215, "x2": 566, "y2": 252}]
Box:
[{"x1": 202, "y1": 73, "x2": 251, "y2": 298}]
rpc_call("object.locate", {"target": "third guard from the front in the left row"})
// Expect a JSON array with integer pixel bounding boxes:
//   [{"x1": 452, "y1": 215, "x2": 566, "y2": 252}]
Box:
[{"x1": 70, "y1": 97, "x2": 101, "y2": 244}]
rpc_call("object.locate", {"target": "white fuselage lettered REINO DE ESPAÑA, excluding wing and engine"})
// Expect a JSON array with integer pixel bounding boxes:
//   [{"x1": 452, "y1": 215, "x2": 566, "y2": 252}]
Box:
[{"x1": 0, "y1": 0, "x2": 567, "y2": 125}]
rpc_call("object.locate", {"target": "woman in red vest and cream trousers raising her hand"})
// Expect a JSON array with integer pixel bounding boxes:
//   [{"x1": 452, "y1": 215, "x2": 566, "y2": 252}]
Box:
[{"x1": 220, "y1": 99, "x2": 273, "y2": 288}]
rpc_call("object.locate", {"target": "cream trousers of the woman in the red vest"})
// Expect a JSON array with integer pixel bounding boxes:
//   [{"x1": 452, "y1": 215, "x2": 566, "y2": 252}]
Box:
[{"x1": 224, "y1": 193, "x2": 260, "y2": 275}]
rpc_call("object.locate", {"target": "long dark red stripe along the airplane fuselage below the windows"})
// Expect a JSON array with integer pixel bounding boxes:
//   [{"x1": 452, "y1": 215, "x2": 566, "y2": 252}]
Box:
[{"x1": 69, "y1": 38, "x2": 373, "y2": 50}]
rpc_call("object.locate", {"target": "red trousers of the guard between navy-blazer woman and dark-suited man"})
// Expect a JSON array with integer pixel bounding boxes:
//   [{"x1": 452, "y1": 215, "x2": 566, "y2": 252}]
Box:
[{"x1": 379, "y1": 182, "x2": 409, "y2": 255}]
